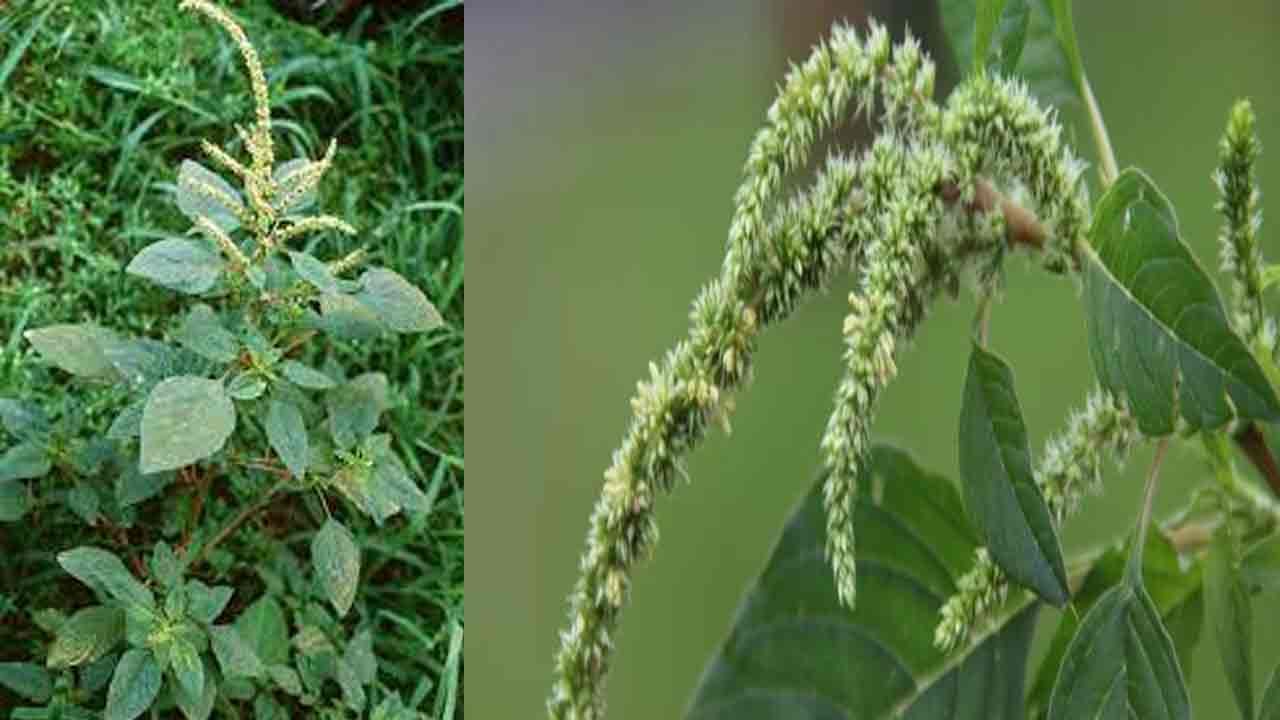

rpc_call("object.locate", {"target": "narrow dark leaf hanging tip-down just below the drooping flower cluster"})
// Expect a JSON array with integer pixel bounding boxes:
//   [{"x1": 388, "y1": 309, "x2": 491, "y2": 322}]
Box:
[{"x1": 960, "y1": 343, "x2": 1070, "y2": 606}]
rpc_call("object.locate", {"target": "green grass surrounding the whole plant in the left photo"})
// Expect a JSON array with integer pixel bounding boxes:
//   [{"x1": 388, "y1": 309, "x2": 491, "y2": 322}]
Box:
[{"x1": 0, "y1": 0, "x2": 465, "y2": 717}]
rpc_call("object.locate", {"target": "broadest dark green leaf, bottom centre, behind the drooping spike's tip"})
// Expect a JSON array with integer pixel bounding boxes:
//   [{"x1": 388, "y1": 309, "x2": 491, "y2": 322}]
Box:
[{"x1": 686, "y1": 446, "x2": 1036, "y2": 720}]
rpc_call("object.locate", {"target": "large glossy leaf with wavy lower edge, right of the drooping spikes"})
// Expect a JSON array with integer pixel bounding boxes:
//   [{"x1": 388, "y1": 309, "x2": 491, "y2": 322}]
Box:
[{"x1": 1083, "y1": 168, "x2": 1280, "y2": 436}]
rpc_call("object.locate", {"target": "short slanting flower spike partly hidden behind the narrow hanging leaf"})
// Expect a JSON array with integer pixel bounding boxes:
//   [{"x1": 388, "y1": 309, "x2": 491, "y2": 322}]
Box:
[{"x1": 933, "y1": 389, "x2": 1139, "y2": 651}]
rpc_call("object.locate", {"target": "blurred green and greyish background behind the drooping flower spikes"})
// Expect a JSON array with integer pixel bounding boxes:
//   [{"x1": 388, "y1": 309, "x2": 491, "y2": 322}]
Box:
[{"x1": 466, "y1": 0, "x2": 1280, "y2": 720}]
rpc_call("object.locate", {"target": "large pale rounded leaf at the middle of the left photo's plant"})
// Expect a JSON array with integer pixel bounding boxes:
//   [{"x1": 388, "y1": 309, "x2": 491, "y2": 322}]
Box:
[{"x1": 140, "y1": 375, "x2": 236, "y2": 473}]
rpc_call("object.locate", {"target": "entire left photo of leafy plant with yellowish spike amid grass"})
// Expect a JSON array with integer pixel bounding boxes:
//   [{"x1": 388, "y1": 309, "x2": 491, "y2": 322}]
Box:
[{"x1": 0, "y1": 0, "x2": 463, "y2": 720}]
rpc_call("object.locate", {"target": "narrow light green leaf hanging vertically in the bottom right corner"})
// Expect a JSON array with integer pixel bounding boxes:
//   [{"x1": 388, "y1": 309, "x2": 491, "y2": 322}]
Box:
[{"x1": 1204, "y1": 528, "x2": 1253, "y2": 720}]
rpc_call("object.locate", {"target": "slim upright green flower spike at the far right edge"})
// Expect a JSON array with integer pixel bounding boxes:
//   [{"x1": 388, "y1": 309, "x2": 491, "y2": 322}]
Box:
[{"x1": 1213, "y1": 100, "x2": 1276, "y2": 350}]
